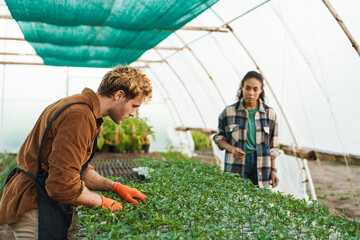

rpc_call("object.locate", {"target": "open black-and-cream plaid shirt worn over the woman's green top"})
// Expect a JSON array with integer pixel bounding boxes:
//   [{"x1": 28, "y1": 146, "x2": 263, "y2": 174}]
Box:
[{"x1": 214, "y1": 99, "x2": 280, "y2": 188}]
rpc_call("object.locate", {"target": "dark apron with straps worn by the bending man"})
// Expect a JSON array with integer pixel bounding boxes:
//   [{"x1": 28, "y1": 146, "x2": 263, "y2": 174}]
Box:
[{"x1": 0, "y1": 102, "x2": 97, "y2": 240}]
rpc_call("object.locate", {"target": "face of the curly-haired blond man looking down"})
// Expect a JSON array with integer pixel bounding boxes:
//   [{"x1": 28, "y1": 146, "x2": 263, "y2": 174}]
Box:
[{"x1": 108, "y1": 90, "x2": 144, "y2": 124}]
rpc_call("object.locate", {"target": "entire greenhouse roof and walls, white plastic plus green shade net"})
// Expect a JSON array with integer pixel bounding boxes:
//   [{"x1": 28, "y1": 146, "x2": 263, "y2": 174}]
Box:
[{"x1": 0, "y1": 0, "x2": 360, "y2": 203}]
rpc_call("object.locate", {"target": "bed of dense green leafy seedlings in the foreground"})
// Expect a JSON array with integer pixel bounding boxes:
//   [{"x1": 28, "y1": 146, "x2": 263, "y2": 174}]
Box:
[{"x1": 76, "y1": 153, "x2": 360, "y2": 239}]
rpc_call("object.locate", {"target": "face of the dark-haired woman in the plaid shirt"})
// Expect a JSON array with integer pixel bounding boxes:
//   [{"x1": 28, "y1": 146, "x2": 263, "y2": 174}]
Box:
[{"x1": 241, "y1": 78, "x2": 263, "y2": 105}]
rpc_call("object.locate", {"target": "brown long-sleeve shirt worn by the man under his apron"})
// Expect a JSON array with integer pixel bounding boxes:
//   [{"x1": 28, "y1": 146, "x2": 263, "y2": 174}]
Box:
[{"x1": 0, "y1": 88, "x2": 103, "y2": 224}]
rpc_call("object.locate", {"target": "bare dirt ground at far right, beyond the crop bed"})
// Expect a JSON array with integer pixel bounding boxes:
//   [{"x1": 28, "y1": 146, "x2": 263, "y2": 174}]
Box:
[{"x1": 308, "y1": 160, "x2": 360, "y2": 221}]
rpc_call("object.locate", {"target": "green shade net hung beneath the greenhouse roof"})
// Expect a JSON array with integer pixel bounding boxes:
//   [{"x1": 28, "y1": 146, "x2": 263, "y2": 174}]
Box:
[{"x1": 6, "y1": 0, "x2": 218, "y2": 68}]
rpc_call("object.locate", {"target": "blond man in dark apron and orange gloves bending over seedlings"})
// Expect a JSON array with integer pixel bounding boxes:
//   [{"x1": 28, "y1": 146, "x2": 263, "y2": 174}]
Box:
[{"x1": 0, "y1": 64, "x2": 152, "y2": 239}]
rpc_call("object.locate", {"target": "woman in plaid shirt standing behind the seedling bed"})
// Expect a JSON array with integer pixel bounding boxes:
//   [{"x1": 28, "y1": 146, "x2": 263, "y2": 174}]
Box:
[{"x1": 214, "y1": 71, "x2": 280, "y2": 188}]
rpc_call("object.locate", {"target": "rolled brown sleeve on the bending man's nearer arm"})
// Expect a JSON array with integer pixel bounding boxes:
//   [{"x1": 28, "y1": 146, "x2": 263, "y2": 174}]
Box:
[{"x1": 46, "y1": 112, "x2": 93, "y2": 204}]
